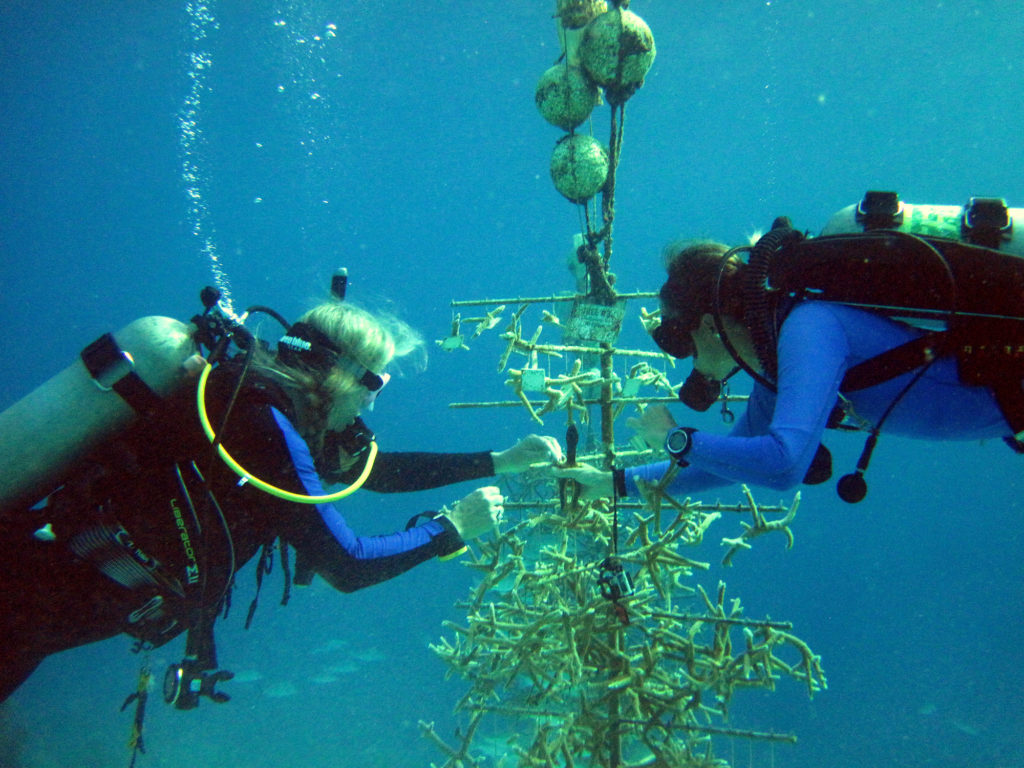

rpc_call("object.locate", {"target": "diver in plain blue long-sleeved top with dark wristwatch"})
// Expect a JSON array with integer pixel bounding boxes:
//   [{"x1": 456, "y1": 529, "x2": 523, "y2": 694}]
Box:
[{"x1": 554, "y1": 243, "x2": 1013, "y2": 501}]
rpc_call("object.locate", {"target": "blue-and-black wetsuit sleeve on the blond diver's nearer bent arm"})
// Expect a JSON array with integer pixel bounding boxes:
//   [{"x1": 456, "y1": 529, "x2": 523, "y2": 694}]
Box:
[{"x1": 272, "y1": 409, "x2": 462, "y2": 592}]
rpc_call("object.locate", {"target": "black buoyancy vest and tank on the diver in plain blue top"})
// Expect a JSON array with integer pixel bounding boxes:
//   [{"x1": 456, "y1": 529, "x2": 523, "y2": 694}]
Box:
[{"x1": 741, "y1": 191, "x2": 1024, "y2": 502}]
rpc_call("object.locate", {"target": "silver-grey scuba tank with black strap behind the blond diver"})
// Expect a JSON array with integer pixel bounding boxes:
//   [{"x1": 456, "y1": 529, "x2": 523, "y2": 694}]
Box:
[{"x1": 0, "y1": 315, "x2": 203, "y2": 514}]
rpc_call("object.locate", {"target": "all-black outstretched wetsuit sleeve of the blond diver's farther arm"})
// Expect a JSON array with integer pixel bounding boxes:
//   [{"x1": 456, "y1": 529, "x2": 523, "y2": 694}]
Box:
[{"x1": 330, "y1": 451, "x2": 495, "y2": 494}]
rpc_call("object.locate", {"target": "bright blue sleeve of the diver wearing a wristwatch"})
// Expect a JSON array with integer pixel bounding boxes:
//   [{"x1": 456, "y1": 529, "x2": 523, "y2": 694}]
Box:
[{"x1": 626, "y1": 302, "x2": 850, "y2": 494}]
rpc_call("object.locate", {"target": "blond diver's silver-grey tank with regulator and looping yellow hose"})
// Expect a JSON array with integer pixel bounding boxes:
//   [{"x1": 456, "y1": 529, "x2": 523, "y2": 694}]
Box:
[{"x1": 0, "y1": 269, "x2": 383, "y2": 514}]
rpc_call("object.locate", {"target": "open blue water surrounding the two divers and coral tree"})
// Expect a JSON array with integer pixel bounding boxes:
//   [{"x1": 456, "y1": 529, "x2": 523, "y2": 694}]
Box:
[{"x1": 0, "y1": 0, "x2": 1024, "y2": 768}]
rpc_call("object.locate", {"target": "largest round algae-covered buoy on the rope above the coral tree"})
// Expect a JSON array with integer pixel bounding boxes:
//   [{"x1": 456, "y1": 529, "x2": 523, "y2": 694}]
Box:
[{"x1": 580, "y1": 8, "x2": 655, "y2": 104}]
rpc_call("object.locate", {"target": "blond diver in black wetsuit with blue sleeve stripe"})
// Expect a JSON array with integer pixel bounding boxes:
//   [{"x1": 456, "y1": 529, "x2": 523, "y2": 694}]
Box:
[{"x1": 0, "y1": 302, "x2": 560, "y2": 708}]
